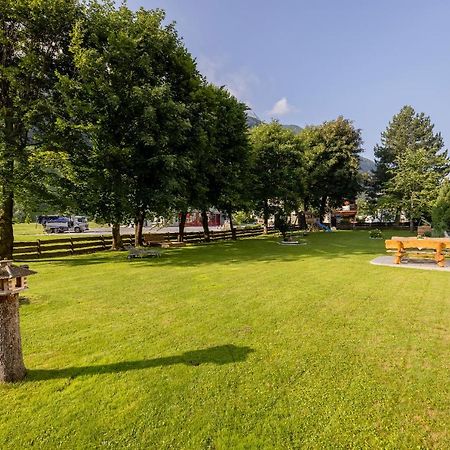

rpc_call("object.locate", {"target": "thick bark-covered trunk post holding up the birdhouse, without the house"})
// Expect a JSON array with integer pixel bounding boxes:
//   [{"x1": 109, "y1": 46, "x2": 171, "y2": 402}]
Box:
[{"x1": 0, "y1": 294, "x2": 26, "y2": 382}]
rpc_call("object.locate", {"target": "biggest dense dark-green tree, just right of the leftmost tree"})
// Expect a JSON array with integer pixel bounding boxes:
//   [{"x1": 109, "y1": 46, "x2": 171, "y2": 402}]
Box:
[{"x1": 55, "y1": 4, "x2": 198, "y2": 248}]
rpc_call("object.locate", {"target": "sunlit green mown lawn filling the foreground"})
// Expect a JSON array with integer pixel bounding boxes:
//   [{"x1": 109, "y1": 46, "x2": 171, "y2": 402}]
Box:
[{"x1": 0, "y1": 232, "x2": 450, "y2": 449}]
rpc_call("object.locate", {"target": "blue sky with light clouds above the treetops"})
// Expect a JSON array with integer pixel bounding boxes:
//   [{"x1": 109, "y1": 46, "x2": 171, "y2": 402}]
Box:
[{"x1": 124, "y1": 0, "x2": 450, "y2": 157}]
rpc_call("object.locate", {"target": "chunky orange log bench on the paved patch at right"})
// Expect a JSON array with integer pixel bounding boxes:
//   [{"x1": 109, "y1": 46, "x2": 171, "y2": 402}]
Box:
[{"x1": 385, "y1": 237, "x2": 450, "y2": 267}]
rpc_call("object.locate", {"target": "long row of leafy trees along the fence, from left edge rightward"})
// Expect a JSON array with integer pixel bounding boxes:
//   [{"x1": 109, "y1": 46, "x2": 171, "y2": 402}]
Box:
[{"x1": 0, "y1": 0, "x2": 361, "y2": 257}]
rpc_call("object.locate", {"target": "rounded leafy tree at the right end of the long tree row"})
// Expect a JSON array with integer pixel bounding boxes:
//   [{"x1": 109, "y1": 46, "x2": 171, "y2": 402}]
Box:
[{"x1": 299, "y1": 116, "x2": 362, "y2": 220}]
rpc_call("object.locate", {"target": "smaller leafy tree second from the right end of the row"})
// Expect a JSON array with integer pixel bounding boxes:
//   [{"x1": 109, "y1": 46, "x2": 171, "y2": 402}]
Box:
[{"x1": 250, "y1": 121, "x2": 305, "y2": 233}]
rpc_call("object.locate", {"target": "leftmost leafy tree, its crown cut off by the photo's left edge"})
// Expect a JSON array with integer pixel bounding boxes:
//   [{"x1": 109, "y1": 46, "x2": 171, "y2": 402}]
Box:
[{"x1": 0, "y1": 0, "x2": 82, "y2": 258}]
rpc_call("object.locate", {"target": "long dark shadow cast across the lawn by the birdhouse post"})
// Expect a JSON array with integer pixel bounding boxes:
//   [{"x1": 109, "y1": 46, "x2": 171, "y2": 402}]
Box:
[{"x1": 26, "y1": 344, "x2": 254, "y2": 381}]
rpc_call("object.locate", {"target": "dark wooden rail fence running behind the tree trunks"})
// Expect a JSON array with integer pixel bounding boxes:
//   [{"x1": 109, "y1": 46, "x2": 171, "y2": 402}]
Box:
[{"x1": 13, "y1": 227, "x2": 276, "y2": 260}]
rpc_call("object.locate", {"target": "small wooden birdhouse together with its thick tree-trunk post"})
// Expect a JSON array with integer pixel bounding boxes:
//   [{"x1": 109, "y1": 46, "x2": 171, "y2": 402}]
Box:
[{"x1": 0, "y1": 259, "x2": 36, "y2": 382}]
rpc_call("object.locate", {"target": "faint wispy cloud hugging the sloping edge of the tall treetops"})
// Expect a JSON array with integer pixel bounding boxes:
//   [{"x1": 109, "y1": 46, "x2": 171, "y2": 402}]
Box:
[{"x1": 197, "y1": 55, "x2": 259, "y2": 106}]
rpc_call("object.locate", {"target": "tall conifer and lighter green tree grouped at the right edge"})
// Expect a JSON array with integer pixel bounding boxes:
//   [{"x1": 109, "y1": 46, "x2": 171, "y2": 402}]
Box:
[{"x1": 368, "y1": 106, "x2": 450, "y2": 231}]
